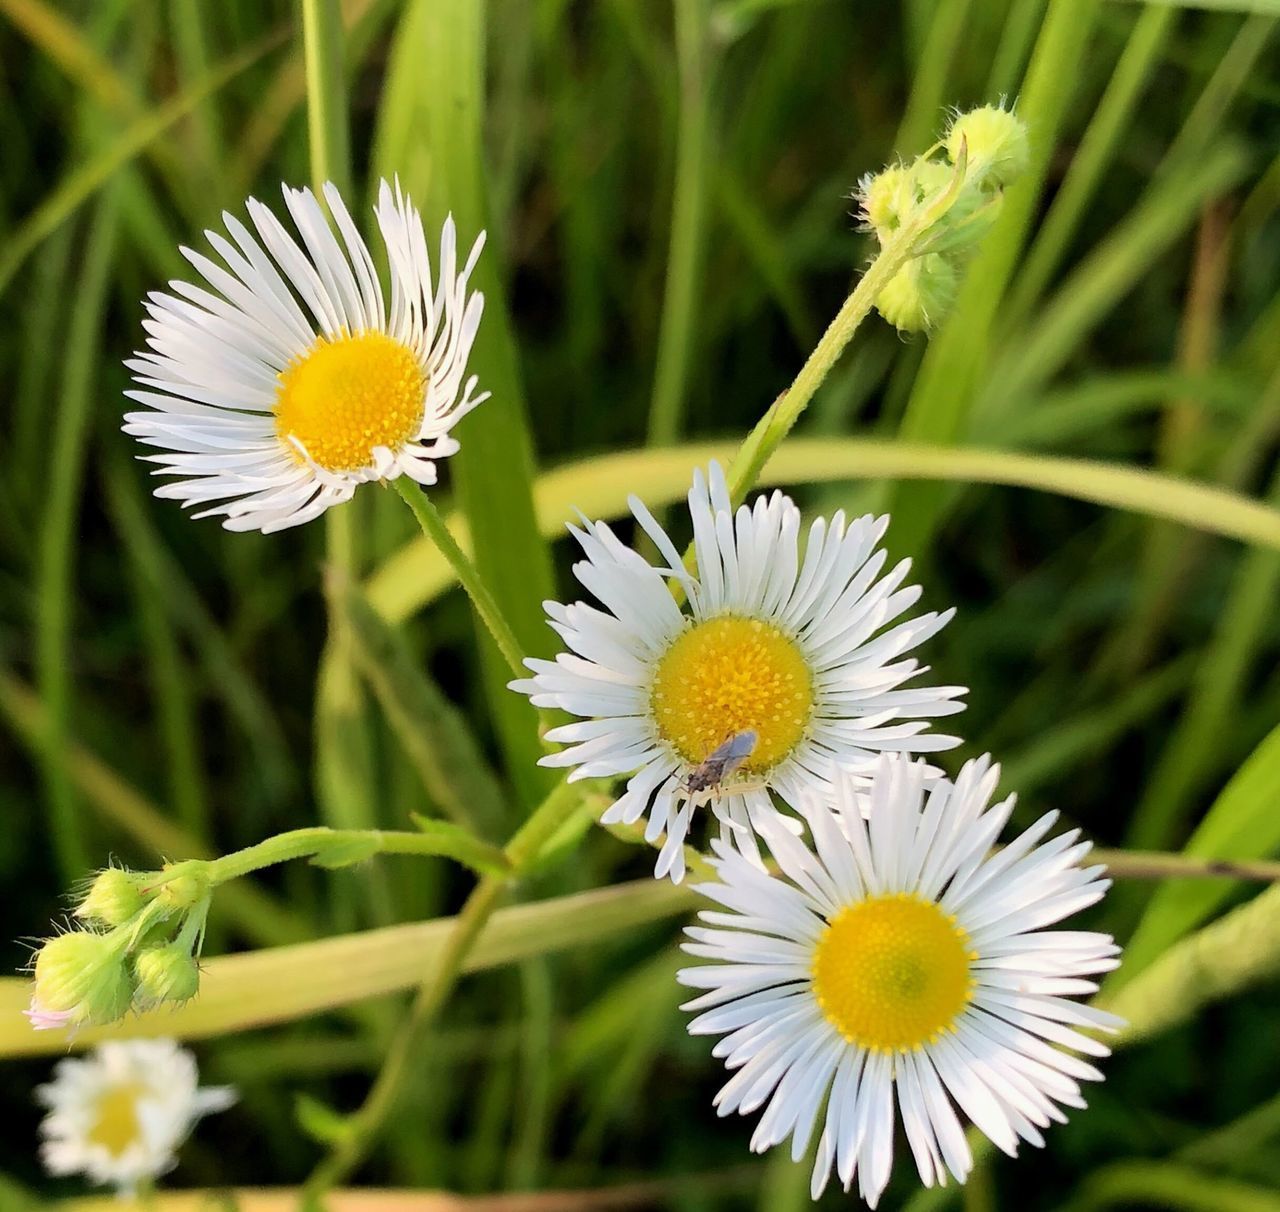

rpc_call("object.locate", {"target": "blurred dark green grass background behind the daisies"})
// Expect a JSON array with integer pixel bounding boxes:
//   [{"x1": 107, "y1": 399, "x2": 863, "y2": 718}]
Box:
[{"x1": 0, "y1": 0, "x2": 1280, "y2": 1212}]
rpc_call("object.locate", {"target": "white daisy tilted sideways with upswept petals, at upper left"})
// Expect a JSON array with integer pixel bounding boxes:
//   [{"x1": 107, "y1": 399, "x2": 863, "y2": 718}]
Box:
[{"x1": 124, "y1": 182, "x2": 488, "y2": 531}]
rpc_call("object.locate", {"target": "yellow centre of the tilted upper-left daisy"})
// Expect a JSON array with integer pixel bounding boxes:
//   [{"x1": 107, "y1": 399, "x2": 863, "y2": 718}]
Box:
[{"x1": 275, "y1": 333, "x2": 426, "y2": 471}]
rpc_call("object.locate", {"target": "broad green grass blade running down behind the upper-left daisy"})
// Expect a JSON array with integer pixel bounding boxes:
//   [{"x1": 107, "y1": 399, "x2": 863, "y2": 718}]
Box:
[{"x1": 374, "y1": 0, "x2": 554, "y2": 804}]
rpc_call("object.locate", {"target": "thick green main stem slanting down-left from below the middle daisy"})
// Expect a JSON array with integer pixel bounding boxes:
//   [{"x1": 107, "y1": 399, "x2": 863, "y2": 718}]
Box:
[{"x1": 302, "y1": 782, "x2": 580, "y2": 1192}]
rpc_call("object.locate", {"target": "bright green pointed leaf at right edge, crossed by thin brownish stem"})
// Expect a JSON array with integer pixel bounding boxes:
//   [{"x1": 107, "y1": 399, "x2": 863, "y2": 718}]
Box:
[{"x1": 1117, "y1": 724, "x2": 1280, "y2": 980}]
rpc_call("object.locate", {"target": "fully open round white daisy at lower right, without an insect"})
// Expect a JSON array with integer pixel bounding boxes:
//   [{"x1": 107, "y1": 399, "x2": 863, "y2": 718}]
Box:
[{"x1": 680, "y1": 756, "x2": 1120, "y2": 1207}]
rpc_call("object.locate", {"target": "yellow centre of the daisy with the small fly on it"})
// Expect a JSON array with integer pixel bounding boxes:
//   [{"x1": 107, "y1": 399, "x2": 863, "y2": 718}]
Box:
[{"x1": 649, "y1": 616, "x2": 813, "y2": 773}]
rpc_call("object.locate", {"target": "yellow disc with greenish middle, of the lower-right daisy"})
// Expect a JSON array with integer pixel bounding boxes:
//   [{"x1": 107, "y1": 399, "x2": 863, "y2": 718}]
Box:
[{"x1": 813, "y1": 893, "x2": 978, "y2": 1052}]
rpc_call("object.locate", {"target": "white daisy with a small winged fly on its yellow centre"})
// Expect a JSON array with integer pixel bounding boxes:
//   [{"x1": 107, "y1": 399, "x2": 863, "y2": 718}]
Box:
[{"x1": 511, "y1": 463, "x2": 964, "y2": 881}]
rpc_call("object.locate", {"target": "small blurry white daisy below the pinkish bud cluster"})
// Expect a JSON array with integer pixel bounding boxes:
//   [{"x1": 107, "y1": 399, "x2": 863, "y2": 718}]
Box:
[{"x1": 36, "y1": 1039, "x2": 236, "y2": 1193}]
